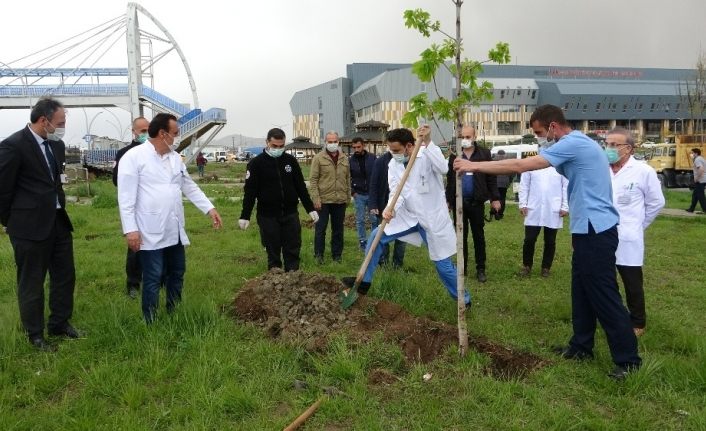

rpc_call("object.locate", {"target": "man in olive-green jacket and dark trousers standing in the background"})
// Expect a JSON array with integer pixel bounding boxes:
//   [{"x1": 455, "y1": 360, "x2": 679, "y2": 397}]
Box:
[{"x1": 309, "y1": 131, "x2": 351, "y2": 264}]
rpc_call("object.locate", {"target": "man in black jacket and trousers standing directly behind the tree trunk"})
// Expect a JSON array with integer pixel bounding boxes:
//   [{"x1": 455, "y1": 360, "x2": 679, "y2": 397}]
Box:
[{"x1": 446, "y1": 126, "x2": 500, "y2": 283}]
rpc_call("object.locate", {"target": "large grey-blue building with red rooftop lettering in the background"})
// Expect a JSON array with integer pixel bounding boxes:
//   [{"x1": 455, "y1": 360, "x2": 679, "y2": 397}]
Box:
[{"x1": 290, "y1": 63, "x2": 695, "y2": 143}]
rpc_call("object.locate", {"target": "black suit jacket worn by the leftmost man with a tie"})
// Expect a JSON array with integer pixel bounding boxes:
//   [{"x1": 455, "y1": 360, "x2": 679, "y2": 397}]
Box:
[{"x1": 0, "y1": 126, "x2": 73, "y2": 241}]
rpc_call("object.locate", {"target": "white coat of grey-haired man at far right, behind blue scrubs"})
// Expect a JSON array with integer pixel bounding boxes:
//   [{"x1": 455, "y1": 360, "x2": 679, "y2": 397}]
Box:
[{"x1": 611, "y1": 156, "x2": 664, "y2": 266}]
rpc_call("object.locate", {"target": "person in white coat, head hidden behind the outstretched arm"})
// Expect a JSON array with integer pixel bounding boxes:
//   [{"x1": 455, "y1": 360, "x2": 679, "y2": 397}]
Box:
[{"x1": 519, "y1": 166, "x2": 569, "y2": 277}]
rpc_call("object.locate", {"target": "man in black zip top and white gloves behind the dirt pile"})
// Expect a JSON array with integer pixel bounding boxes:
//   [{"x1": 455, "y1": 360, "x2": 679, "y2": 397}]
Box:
[{"x1": 238, "y1": 128, "x2": 319, "y2": 271}]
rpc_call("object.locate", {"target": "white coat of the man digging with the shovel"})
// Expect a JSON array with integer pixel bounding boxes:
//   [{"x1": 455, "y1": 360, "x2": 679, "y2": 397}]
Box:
[{"x1": 385, "y1": 142, "x2": 456, "y2": 261}]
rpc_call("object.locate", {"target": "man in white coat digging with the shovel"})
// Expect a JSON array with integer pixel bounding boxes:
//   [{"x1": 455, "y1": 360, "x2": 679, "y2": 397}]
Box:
[{"x1": 342, "y1": 125, "x2": 471, "y2": 306}]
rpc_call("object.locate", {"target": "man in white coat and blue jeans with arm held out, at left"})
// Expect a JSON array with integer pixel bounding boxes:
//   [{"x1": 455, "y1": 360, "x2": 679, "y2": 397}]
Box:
[{"x1": 118, "y1": 114, "x2": 221, "y2": 323}]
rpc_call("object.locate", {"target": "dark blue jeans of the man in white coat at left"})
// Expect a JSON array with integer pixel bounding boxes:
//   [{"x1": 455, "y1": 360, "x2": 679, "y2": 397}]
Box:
[{"x1": 139, "y1": 242, "x2": 186, "y2": 323}]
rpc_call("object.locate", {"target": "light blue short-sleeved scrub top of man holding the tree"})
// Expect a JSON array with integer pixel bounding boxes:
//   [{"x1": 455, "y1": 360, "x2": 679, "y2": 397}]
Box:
[{"x1": 541, "y1": 131, "x2": 620, "y2": 233}]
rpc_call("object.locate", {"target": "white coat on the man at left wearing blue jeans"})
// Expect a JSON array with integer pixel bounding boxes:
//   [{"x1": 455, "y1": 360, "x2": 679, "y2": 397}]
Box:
[{"x1": 118, "y1": 142, "x2": 214, "y2": 250}]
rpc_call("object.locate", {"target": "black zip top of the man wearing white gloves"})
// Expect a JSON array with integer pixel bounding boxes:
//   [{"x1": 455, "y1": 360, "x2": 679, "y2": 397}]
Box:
[{"x1": 240, "y1": 151, "x2": 314, "y2": 220}]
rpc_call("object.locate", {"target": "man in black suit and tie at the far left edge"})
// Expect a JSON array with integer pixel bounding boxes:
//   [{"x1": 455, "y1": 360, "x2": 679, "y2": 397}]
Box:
[{"x1": 0, "y1": 98, "x2": 79, "y2": 351}]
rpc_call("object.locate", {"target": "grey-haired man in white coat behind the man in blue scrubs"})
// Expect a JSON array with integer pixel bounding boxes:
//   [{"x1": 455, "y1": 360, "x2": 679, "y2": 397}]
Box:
[{"x1": 605, "y1": 128, "x2": 664, "y2": 336}]
